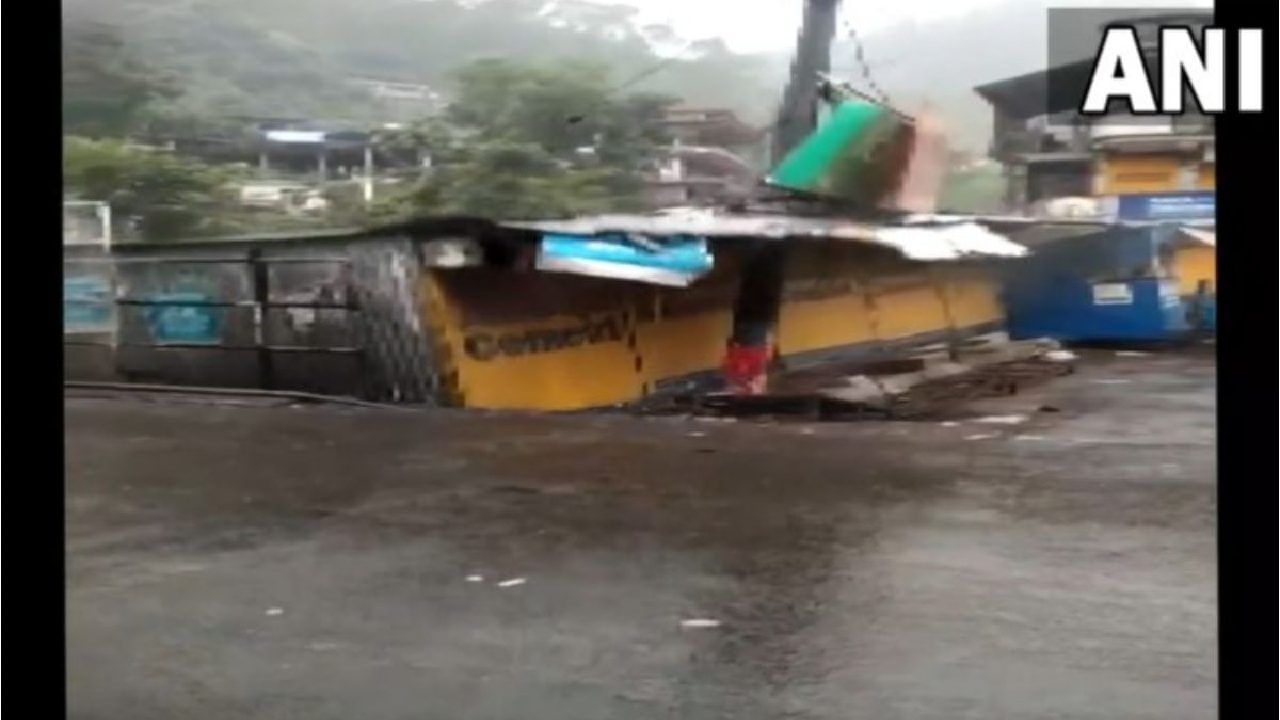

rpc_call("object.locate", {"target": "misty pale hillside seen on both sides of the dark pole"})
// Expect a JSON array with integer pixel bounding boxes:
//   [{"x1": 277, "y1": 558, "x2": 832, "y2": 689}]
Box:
[{"x1": 64, "y1": 0, "x2": 1090, "y2": 150}]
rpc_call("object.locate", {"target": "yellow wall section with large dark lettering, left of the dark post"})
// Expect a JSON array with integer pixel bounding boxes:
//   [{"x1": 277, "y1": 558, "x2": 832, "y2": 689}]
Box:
[{"x1": 424, "y1": 258, "x2": 737, "y2": 410}]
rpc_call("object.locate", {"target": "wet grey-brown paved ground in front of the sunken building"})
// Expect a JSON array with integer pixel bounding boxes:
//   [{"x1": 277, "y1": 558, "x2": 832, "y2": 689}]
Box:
[{"x1": 67, "y1": 352, "x2": 1216, "y2": 720}]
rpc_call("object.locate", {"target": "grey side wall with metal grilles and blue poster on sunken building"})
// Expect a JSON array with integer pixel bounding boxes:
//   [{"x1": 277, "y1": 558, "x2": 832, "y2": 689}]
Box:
[{"x1": 64, "y1": 240, "x2": 436, "y2": 404}]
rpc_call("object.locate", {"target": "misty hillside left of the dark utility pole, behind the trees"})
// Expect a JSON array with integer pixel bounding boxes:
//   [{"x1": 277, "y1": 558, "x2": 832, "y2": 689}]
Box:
[{"x1": 64, "y1": 0, "x2": 783, "y2": 122}]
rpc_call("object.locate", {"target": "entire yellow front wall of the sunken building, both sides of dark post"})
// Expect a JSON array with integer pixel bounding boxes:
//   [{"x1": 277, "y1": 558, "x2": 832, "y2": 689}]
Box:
[{"x1": 424, "y1": 243, "x2": 1002, "y2": 410}]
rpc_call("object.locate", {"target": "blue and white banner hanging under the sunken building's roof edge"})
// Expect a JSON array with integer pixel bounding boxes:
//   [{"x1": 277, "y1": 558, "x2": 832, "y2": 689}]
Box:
[{"x1": 536, "y1": 234, "x2": 714, "y2": 287}]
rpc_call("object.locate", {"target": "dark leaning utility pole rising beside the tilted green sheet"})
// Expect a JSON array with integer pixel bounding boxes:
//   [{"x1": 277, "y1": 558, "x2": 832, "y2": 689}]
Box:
[{"x1": 771, "y1": 0, "x2": 840, "y2": 164}]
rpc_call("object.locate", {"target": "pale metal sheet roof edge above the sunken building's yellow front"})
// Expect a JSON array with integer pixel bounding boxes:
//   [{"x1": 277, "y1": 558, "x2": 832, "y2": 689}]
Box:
[{"x1": 500, "y1": 209, "x2": 1027, "y2": 261}]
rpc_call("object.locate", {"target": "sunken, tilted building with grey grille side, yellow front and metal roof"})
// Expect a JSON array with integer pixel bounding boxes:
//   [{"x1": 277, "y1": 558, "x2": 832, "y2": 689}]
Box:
[{"x1": 67, "y1": 210, "x2": 1021, "y2": 410}]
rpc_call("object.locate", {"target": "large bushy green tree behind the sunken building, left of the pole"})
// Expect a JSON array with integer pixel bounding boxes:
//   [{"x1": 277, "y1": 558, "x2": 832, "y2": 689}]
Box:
[{"x1": 375, "y1": 59, "x2": 672, "y2": 219}]
